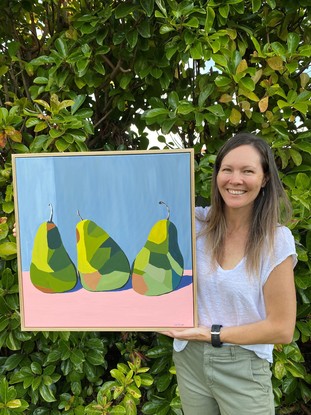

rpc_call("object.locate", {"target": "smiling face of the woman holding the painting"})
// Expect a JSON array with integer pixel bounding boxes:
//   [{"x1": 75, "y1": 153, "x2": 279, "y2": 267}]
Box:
[{"x1": 217, "y1": 145, "x2": 266, "y2": 213}]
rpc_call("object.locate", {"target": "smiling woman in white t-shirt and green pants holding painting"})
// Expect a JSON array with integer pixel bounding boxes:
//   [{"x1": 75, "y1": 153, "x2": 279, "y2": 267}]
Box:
[{"x1": 164, "y1": 133, "x2": 297, "y2": 415}]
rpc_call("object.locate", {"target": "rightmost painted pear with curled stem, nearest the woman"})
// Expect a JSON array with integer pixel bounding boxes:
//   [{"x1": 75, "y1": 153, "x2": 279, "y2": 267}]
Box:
[{"x1": 132, "y1": 201, "x2": 184, "y2": 296}]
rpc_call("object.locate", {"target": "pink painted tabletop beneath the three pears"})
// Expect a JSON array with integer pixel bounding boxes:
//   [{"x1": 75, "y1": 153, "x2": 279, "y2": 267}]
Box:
[{"x1": 21, "y1": 272, "x2": 194, "y2": 331}]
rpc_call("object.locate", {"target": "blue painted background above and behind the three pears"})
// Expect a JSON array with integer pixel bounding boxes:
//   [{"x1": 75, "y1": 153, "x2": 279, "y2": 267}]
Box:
[{"x1": 15, "y1": 151, "x2": 193, "y2": 271}]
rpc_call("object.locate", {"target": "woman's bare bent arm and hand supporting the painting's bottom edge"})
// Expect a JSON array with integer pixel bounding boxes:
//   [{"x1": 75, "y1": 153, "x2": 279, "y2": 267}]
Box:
[{"x1": 162, "y1": 257, "x2": 296, "y2": 345}]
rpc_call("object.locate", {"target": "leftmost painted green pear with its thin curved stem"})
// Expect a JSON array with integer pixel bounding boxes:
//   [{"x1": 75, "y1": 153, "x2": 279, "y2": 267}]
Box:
[{"x1": 30, "y1": 205, "x2": 79, "y2": 293}]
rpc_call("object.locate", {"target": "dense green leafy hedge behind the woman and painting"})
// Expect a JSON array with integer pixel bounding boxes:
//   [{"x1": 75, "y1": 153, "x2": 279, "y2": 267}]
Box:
[{"x1": 0, "y1": 0, "x2": 311, "y2": 415}]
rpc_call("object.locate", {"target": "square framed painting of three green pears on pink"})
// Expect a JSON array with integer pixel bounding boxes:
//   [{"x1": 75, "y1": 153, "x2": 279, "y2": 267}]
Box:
[{"x1": 13, "y1": 149, "x2": 196, "y2": 331}]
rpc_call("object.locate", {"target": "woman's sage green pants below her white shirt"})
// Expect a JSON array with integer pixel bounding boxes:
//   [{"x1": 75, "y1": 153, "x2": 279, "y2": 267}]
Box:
[{"x1": 173, "y1": 341, "x2": 275, "y2": 415}]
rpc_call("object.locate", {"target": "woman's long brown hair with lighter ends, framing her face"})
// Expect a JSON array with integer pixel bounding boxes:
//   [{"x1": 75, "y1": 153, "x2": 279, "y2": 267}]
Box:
[{"x1": 206, "y1": 133, "x2": 291, "y2": 275}]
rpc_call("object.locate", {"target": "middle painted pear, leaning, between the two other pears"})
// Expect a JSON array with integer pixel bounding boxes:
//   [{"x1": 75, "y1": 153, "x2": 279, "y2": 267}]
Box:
[{"x1": 76, "y1": 214, "x2": 130, "y2": 291}]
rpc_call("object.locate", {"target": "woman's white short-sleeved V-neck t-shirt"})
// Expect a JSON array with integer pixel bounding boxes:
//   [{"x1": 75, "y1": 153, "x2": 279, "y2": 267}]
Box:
[{"x1": 174, "y1": 207, "x2": 297, "y2": 363}]
